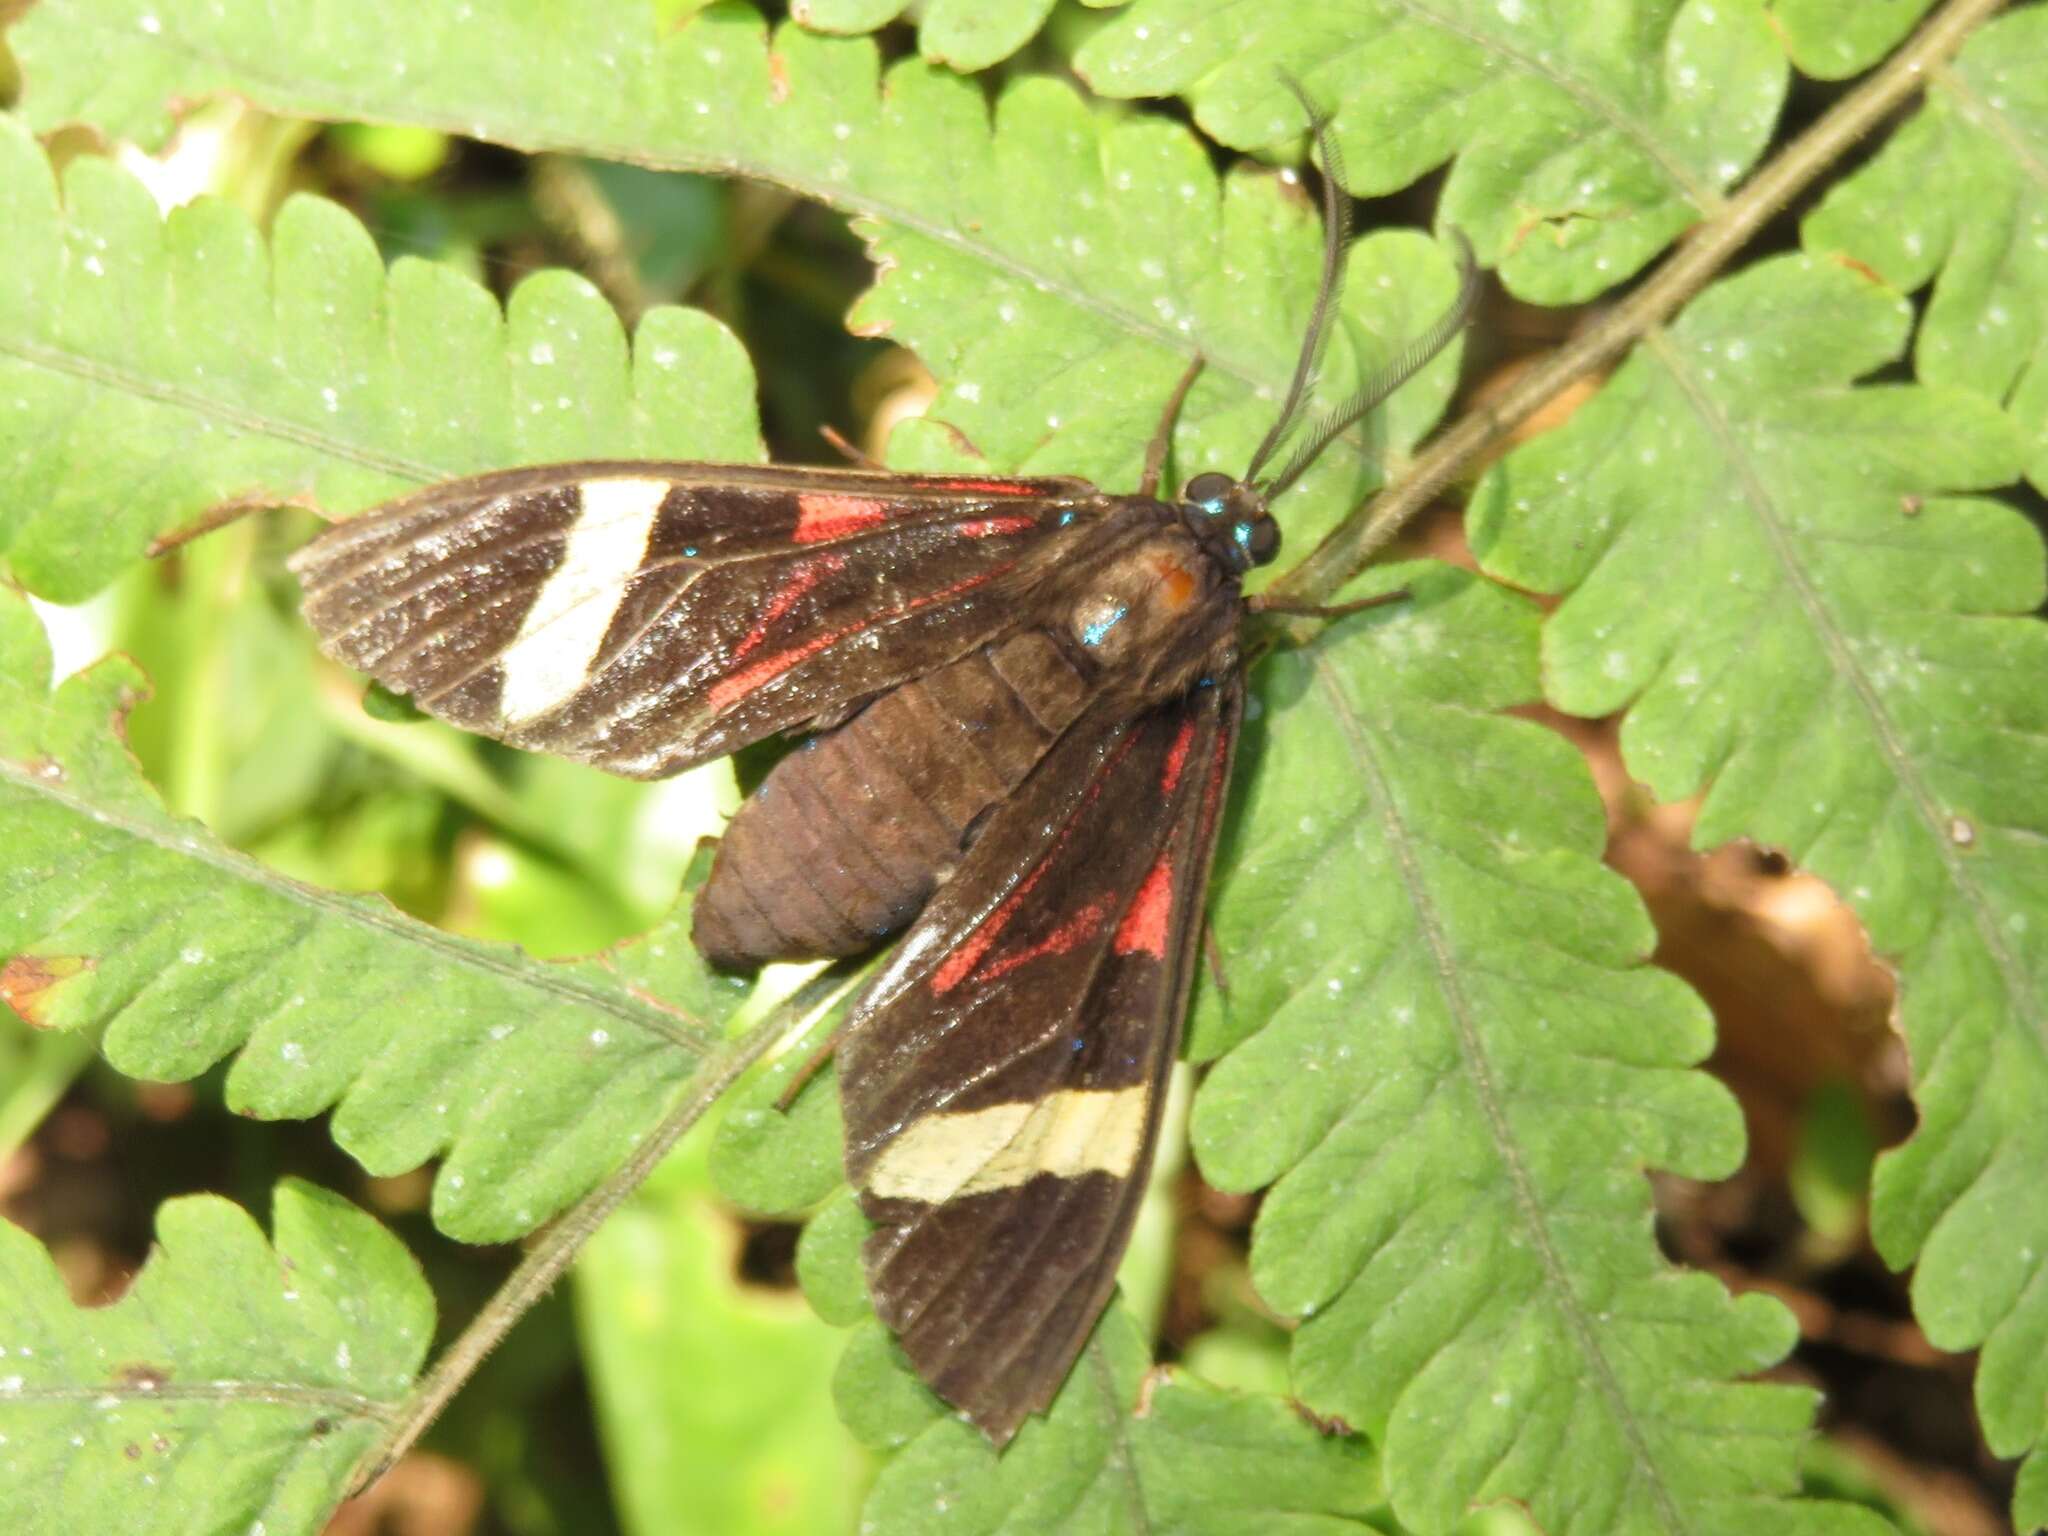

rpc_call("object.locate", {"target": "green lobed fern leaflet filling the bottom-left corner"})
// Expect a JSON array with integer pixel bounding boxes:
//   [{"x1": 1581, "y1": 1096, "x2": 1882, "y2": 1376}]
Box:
[{"x1": 0, "y1": 1180, "x2": 434, "y2": 1536}]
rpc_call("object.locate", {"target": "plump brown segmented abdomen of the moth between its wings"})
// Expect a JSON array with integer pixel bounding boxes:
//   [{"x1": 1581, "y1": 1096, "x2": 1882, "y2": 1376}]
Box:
[{"x1": 692, "y1": 631, "x2": 1090, "y2": 969}]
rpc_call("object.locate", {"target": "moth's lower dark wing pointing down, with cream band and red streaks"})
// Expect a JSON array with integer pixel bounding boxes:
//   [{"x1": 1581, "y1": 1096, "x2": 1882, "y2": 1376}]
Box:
[{"x1": 838, "y1": 659, "x2": 1243, "y2": 1444}]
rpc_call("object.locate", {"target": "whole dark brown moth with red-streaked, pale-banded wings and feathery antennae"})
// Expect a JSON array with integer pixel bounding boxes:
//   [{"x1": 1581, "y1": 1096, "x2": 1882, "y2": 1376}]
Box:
[{"x1": 291, "y1": 108, "x2": 1477, "y2": 1444}]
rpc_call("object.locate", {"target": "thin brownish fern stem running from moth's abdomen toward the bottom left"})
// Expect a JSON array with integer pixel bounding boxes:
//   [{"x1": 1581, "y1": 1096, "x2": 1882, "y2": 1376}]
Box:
[{"x1": 337, "y1": 987, "x2": 823, "y2": 1495}]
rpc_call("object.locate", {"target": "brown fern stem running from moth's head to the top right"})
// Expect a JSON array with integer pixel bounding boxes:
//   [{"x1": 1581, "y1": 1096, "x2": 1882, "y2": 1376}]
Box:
[{"x1": 1268, "y1": 0, "x2": 2005, "y2": 602}]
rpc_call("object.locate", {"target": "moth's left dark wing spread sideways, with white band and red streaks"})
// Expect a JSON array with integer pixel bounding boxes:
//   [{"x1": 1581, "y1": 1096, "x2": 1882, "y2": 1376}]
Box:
[{"x1": 291, "y1": 463, "x2": 1102, "y2": 778}]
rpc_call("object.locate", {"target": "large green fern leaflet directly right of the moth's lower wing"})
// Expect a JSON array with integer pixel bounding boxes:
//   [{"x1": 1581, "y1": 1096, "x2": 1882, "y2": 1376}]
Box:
[{"x1": 1194, "y1": 567, "x2": 1884, "y2": 1536}]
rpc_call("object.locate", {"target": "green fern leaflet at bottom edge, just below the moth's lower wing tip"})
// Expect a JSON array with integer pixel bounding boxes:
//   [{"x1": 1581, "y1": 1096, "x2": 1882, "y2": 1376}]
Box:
[{"x1": 864, "y1": 1307, "x2": 1378, "y2": 1536}]
